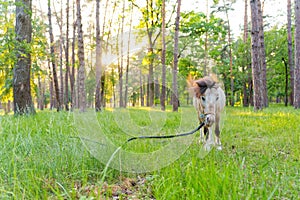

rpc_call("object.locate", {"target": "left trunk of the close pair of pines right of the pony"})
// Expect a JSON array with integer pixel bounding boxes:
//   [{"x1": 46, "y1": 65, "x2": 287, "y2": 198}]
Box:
[{"x1": 250, "y1": 0, "x2": 263, "y2": 110}]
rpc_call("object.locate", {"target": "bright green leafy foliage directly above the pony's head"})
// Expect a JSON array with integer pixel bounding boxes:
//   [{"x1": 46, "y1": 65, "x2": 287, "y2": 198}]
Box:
[{"x1": 179, "y1": 11, "x2": 227, "y2": 73}]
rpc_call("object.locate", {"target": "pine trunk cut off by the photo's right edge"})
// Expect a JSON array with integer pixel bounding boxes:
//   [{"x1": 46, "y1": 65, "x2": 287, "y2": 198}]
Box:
[{"x1": 294, "y1": 0, "x2": 300, "y2": 109}]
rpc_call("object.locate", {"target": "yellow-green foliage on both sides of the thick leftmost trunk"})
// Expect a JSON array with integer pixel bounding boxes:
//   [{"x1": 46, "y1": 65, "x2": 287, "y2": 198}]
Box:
[{"x1": 0, "y1": 1, "x2": 47, "y2": 102}]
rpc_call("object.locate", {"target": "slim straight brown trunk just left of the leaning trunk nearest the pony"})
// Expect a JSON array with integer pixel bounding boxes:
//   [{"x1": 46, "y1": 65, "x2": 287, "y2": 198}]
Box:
[{"x1": 160, "y1": 0, "x2": 166, "y2": 111}]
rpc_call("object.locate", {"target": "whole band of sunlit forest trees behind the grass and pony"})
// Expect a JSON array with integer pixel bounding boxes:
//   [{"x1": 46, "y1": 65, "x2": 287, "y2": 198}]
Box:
[{"x1": 0, "y1": 0, "x2": 300, "y2": 114}]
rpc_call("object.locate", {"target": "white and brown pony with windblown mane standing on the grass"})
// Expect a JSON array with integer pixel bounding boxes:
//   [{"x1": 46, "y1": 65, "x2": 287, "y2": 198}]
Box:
[{"x1": 192, "y1": 76, "x2": 226, "y2": 150}]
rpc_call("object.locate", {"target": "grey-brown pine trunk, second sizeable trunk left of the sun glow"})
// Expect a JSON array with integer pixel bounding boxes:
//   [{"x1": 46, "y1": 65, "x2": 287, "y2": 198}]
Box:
[{"x1": 76, "y1": 0, "x2": 86, "y2": 112}]
